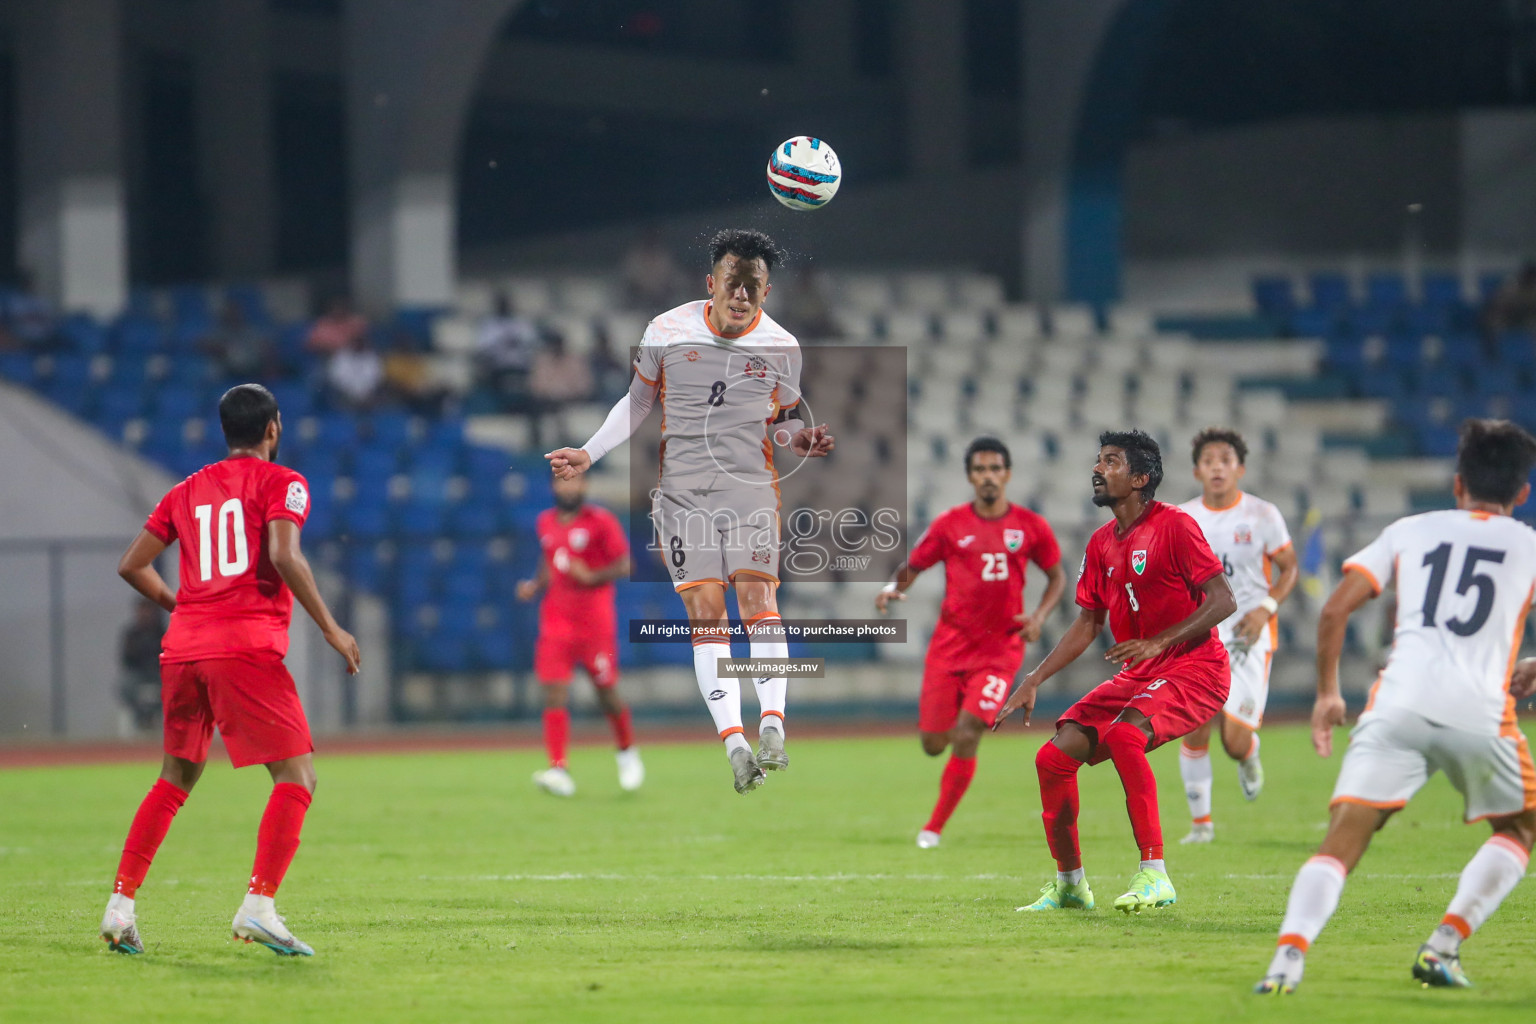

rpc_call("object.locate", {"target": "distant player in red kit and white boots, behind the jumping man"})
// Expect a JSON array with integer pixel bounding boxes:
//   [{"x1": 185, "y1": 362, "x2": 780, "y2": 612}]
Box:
[{"x1": 518, "y1": 476, "x2": 645, "y2": 797}]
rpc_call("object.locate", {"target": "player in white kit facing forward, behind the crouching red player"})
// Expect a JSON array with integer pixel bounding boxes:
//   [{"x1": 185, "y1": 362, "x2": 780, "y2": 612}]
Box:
[{"x1": 1178, "y1": 427, "x2": 1298, "y2": 843}]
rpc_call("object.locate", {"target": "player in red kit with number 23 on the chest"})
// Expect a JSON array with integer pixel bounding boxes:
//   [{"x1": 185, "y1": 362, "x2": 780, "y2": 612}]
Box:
[{"x1": 874, "y1": 438, "x2": 1066, "y2": 849}]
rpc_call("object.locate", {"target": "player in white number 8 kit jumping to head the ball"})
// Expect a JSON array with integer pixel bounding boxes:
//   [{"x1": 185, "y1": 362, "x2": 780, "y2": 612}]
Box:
[{"x1": 545, "y1": 230, "x2": 833, "y2": 792}]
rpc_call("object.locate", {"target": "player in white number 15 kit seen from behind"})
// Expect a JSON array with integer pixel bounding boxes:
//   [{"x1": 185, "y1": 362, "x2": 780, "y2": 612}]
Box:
[{"x1": 1255, "y1": 419, "x2": 1536, "y2": 993}]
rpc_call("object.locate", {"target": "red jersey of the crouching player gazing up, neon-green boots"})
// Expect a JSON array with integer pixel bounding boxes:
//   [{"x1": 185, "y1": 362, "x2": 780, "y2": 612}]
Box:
[{"x1": 1077, "y1": 502, "x2": 1224, "y2": 672}]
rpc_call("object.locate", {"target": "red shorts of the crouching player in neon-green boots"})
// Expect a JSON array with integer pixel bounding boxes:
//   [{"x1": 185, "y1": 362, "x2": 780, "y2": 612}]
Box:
[{"x1": 1057, "y1": 657, "x2": 1232, "y2": 765}]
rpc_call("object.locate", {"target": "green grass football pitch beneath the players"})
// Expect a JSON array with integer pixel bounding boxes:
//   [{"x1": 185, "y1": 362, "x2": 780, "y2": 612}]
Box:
[{"x1": 0, "y1": 725, "x2": 1536, "y2": 1022}]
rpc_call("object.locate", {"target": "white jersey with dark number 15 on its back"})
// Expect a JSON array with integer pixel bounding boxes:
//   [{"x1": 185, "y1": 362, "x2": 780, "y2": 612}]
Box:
[{"x1": 1344, "y1": 510, "x2": 1536, "y2": 735}]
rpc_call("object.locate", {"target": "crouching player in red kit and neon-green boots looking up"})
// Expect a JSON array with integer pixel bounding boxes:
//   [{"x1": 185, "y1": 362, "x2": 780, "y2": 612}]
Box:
[{"x1": 992, "y1": 430, "x2": 1236, "y2": 913}]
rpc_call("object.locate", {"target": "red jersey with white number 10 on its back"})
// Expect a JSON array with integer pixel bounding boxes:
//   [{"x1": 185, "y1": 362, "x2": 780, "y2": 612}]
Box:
[{"x1": 144, "y1": 457, "x2": 309, "y2": 662}]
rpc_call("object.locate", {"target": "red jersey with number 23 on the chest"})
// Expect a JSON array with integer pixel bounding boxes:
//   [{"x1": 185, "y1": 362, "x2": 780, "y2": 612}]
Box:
[{"x1": 906, "y1": 502, "x2": 1061, "y2": 669}]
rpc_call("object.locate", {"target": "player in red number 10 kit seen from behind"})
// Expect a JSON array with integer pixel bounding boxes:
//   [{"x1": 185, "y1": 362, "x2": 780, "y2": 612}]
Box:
[{"x1": 101, "y1": 384, "x2": 362, "y2": 956}]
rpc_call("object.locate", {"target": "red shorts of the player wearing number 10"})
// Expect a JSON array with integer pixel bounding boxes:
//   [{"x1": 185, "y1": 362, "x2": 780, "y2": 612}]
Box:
[{"x1": 160, "y1": 654, "x2": 315, "y2": 768}]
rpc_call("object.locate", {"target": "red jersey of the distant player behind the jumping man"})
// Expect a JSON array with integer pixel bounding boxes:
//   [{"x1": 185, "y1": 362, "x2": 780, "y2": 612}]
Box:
[{"x1": 535, "y1": 504, "x2": 630, "y2": 636}]
